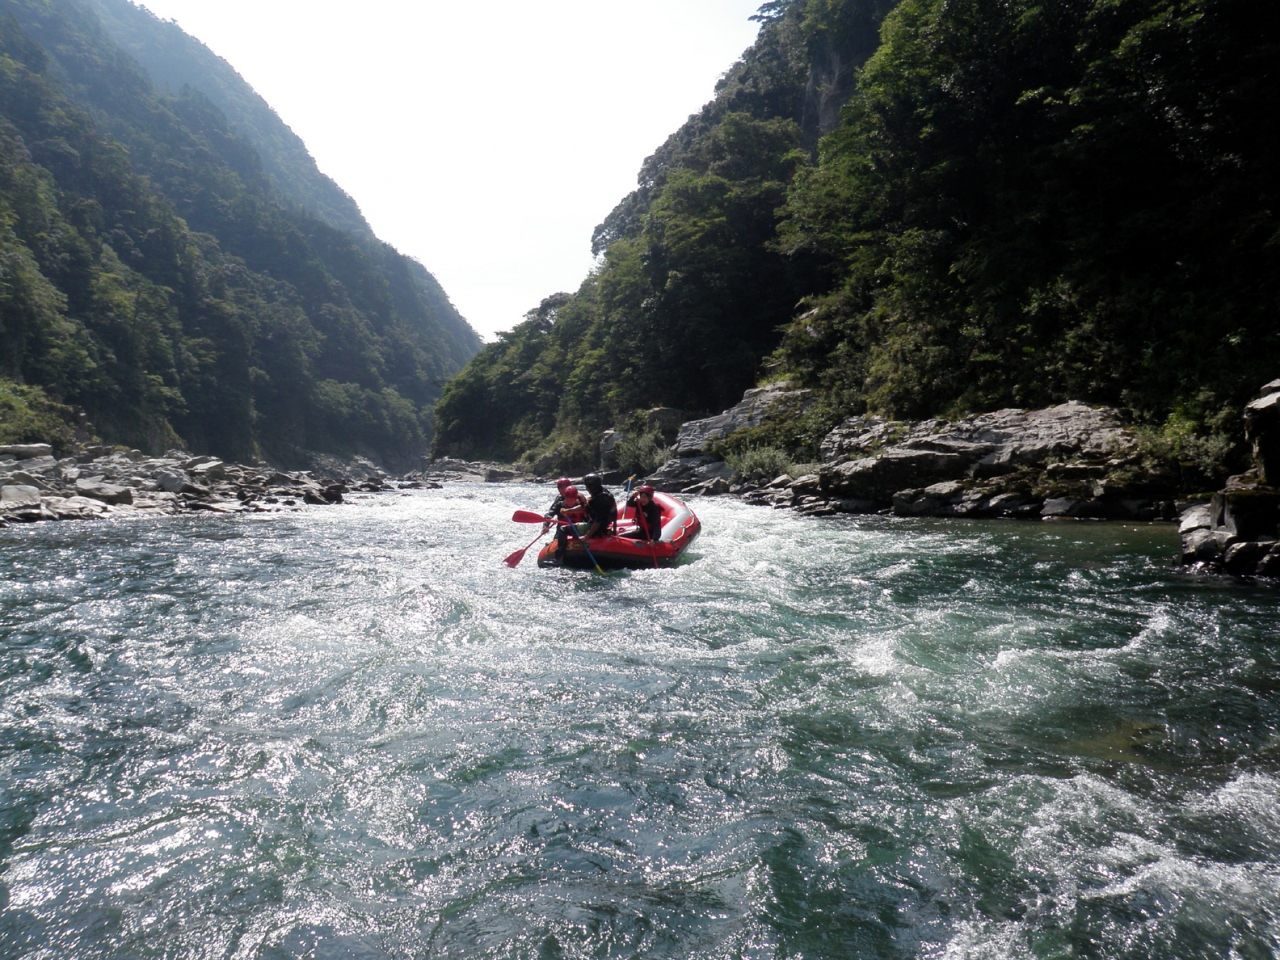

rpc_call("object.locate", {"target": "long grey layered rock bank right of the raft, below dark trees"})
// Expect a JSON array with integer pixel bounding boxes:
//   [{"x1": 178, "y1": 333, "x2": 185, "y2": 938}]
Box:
[{"x1": 650, "y1": 384, "x2": 1179, "y2": 520}]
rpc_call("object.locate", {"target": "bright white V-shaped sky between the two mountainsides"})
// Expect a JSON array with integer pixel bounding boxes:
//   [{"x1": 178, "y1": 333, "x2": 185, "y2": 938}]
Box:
[{"x1": 137, "y1": 0, "x2": 762, "y2": 340}]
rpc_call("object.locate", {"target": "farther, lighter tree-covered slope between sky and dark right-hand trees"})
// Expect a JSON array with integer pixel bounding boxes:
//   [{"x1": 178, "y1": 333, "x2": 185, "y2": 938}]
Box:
[{"x1": 435, "y1": 0, "x2": 888, "y2": 468}]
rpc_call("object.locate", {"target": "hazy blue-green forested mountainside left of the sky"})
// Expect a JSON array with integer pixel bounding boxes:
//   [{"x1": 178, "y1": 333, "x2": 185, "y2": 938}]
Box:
[{"x1": 0, "y1": 0, "x2": 479, "y2": 463}]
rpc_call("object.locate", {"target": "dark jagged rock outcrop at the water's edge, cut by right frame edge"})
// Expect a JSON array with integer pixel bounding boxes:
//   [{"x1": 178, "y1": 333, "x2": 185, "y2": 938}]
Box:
[{"x1": 1179, "y1": 380, "x2": 1280, "y2": 577}]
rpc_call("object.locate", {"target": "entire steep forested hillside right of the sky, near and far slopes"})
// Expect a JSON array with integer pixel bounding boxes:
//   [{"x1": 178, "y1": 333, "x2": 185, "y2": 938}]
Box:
[{"x1": 436, "y1": 0, "x2": 1280, "y2": 467}]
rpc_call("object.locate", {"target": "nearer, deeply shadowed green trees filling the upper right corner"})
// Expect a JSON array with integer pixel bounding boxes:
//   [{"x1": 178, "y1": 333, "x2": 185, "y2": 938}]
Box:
[{"x1": 778, "y1": 0, "x2": 1280, "y2": 432}]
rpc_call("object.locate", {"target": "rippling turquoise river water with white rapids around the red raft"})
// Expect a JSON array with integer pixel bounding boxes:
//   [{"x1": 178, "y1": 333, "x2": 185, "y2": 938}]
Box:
[{"x1": 0, "y1": 484, "x2": 1280, "y2": 960}]
